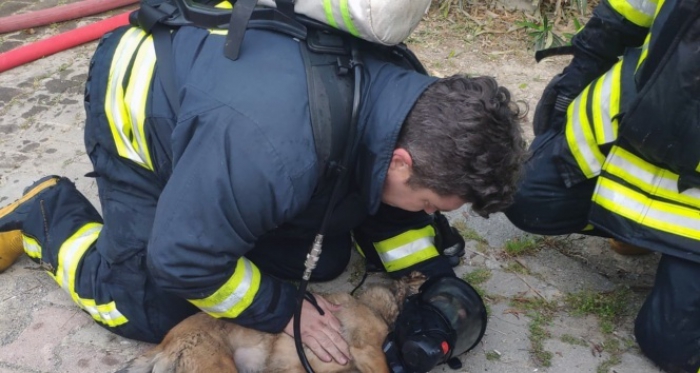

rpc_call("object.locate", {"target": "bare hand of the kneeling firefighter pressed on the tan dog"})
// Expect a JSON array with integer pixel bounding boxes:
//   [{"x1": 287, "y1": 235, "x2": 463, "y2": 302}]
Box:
[{"x1": 284, "y1": 295, "x2": 350, "y2": 365}]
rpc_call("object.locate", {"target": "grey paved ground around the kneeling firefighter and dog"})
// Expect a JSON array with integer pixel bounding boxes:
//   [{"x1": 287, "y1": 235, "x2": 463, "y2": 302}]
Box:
[{"x1": 0, "y1": 0, "x2": 658, "y2": 373}]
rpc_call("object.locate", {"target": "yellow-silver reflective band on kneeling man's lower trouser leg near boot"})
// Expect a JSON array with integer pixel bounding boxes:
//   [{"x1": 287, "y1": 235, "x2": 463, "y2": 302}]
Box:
[{"x1": 49, "y1": 223, "x2": 129, "y2": 327}]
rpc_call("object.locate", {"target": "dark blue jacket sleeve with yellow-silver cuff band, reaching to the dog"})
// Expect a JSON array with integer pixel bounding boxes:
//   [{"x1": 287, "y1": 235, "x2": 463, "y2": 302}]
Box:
[{"x1": 148, "y1": 103, "x2": 315, "y2": 333}]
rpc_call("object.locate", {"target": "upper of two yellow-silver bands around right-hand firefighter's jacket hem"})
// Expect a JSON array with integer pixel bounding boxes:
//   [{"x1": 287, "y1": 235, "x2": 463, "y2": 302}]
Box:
[{"x1": 603, "y1": 146, "x2": 700, "y2": 209}]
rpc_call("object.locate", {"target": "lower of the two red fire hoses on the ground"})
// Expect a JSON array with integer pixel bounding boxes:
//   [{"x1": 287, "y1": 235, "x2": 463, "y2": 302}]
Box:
[{"x1": 0, "y1": 11, "x2": 131, "y2": 73}]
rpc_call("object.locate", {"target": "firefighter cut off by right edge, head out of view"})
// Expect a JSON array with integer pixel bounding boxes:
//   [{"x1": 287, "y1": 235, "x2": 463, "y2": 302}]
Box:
[{"x1": 506, "y1": 0, "x2": 700, "y2": 372}]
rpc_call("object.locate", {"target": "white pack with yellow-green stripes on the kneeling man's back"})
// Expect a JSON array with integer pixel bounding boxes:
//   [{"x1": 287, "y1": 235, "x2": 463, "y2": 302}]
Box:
[{"x1": 258, "y1": 0, "x2": 431, "y2": 45}]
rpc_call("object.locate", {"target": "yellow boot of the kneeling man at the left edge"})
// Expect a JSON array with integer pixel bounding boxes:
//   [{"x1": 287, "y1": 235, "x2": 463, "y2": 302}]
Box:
[{"x1": 0, "y1": 176, "x2": 60, "y2": 272}]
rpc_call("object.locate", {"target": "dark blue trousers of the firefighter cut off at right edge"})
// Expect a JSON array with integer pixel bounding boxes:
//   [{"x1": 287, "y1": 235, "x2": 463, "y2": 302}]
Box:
[{"x1": 505, "y1": 130, "x2": 700, "y2": 373}]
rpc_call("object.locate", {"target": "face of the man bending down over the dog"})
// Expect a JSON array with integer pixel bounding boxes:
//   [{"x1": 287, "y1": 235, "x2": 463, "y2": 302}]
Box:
[{"x1": 382, "y1": 148, "x2": 465, "y2": 214}]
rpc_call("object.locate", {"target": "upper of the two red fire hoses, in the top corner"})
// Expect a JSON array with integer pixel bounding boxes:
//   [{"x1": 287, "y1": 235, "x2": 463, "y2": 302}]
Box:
[{"x1": 0, "y1": 0, "x2": 139, "y2": 34}]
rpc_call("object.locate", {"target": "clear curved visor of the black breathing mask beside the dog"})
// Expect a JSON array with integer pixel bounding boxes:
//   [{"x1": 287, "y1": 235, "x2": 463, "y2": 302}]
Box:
[{"x1": 420, "y1": 277, "x2": 487, "y2": 356}]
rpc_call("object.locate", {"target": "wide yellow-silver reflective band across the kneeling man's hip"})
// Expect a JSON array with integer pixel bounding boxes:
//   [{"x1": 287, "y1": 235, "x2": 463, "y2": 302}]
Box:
[{"x1": 105, "y1": 28, "x2": 156, "y2": 170}]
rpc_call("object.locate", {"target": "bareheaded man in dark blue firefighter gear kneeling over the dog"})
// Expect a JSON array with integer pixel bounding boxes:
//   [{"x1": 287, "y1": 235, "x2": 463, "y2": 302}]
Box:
[{"x1": 0, "y1": 3, "x2": 525, "y2": 367}]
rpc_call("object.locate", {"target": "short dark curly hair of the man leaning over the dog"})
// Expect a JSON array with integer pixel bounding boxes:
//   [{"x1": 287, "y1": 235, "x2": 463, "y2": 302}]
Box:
[{"x1": 397, "y1": 75, "x2": 527, "y2": 217}]
